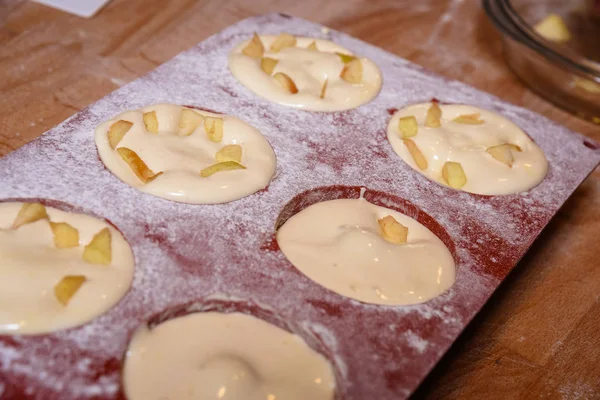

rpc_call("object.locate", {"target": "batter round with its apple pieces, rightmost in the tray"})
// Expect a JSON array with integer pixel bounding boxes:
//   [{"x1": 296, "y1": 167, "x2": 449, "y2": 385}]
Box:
[{"x1": 388, "y1": 102, "x2": 548, "y2": 195}]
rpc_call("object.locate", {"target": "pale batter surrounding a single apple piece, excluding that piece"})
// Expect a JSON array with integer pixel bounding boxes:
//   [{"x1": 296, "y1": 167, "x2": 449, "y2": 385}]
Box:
[{"x1": 277, "y1": 199, "x2": 455, "y2": 305}]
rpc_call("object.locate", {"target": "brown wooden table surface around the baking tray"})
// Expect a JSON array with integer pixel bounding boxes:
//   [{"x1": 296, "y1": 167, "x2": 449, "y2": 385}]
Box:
[{"x1": 0, "y1": 0, "x2": 600, "y2": 399}]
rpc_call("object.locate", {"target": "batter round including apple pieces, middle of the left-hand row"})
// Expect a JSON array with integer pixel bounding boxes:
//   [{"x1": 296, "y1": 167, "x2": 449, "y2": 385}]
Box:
[{"x1": 96, "y1": 104, "x2": 276, "y2": 204}]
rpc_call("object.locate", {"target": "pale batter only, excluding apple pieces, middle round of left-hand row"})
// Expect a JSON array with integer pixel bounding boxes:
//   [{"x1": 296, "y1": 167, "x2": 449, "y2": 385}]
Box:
[{"x1": 96, "y1": 104, "x2": 276, "y2": 204}]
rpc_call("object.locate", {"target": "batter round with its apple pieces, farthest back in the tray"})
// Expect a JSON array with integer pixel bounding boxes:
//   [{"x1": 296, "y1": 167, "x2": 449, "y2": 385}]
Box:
[{"x1": 229, "y1": 33, "x2": 382, "y2": 111}]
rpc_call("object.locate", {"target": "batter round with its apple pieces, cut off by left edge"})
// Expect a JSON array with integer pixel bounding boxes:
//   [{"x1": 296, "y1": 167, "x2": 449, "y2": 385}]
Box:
[{"x1": 0, "y1": 202, "x2": 134, "y2": 334}]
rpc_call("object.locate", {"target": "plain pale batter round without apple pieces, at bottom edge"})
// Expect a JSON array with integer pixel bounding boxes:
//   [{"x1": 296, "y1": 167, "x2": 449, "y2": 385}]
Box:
[{"x1": 123, "y1": 312, "x2": 335, "y2": 400}]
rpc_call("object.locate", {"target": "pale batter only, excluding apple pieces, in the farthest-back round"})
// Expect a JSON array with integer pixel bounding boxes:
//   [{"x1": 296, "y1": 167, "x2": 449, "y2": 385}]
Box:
[{"x1": 229, "y1": 35, "x2": 382, "y2": 111}]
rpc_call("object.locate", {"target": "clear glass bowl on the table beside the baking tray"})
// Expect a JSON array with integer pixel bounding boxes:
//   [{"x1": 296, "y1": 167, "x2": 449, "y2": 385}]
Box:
[{"x1": 483, "y1": 0, "x2": 600, "y2": 125}]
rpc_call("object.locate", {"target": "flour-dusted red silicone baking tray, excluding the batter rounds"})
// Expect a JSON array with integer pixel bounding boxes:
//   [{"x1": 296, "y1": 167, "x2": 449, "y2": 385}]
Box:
[{"x1": 0, "y1": 14, "x2": 600, "y2": 400}]
